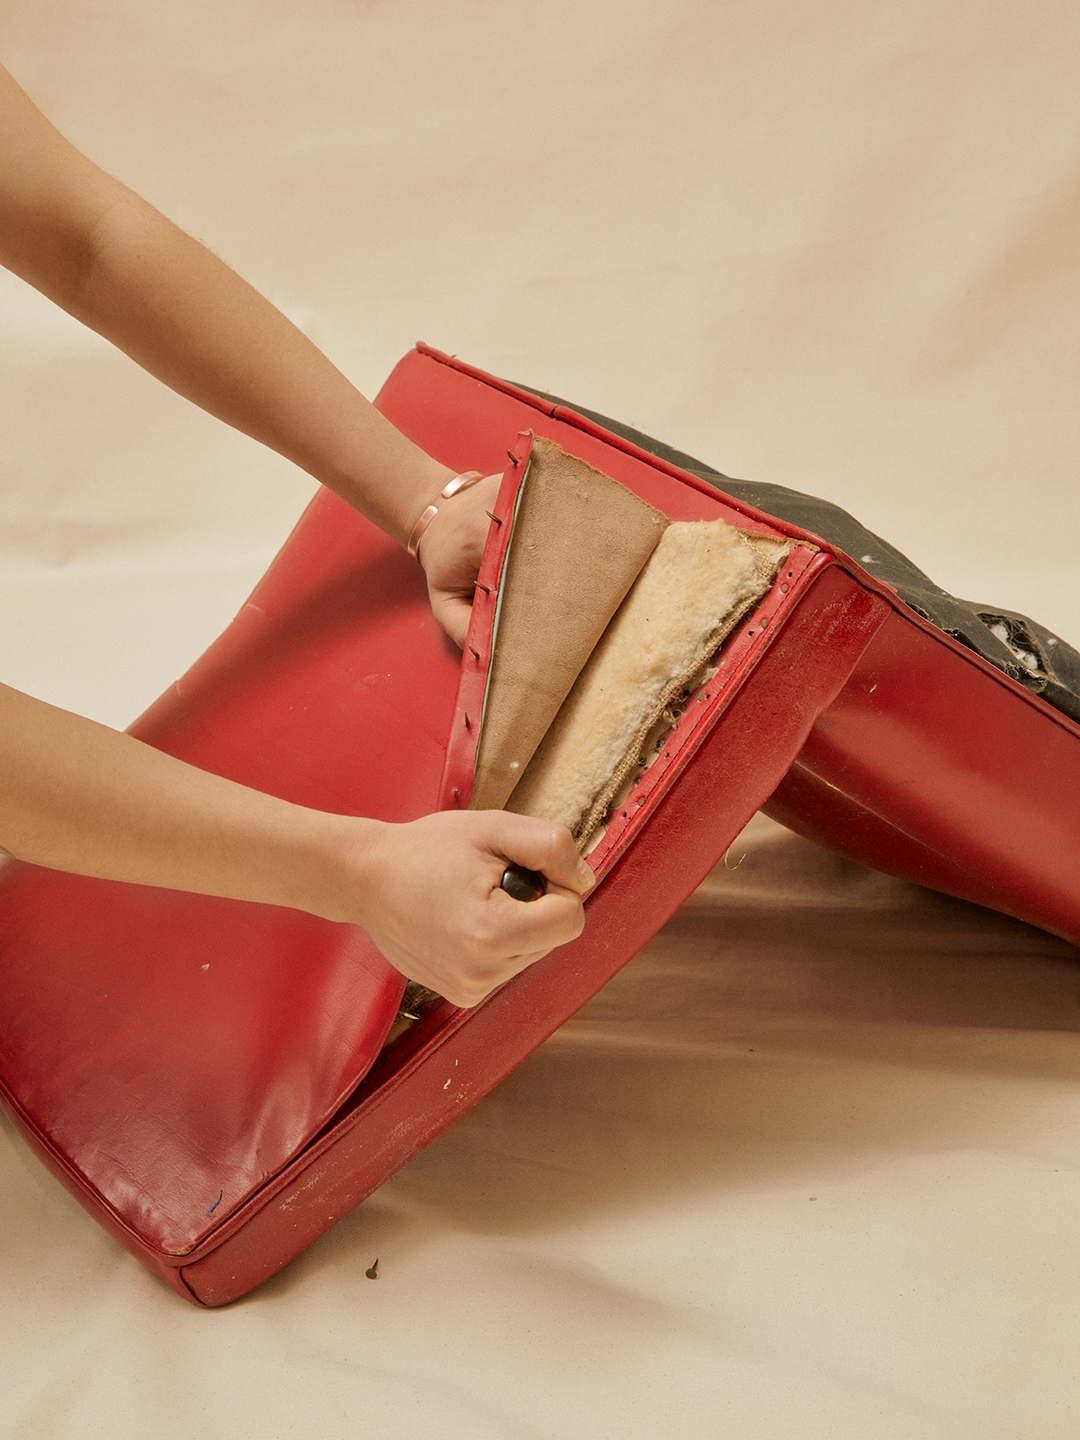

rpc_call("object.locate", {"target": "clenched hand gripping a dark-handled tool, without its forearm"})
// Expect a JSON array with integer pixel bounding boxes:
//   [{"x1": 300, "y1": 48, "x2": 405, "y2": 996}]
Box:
[{"x1": 344, "y1": 811, "x2": 593, "y2": 1008}]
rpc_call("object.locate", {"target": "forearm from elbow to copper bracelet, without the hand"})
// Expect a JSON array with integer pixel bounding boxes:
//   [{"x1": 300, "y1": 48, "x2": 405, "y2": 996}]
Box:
[{"x1": 73, "y1": 189, "x2": 452, "y2": 544}]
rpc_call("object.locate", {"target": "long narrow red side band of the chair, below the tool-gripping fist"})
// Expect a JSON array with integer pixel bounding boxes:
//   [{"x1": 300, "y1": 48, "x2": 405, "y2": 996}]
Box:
[{"x1": 183, "y1": 563, "x2": 888, "y2": 1306}]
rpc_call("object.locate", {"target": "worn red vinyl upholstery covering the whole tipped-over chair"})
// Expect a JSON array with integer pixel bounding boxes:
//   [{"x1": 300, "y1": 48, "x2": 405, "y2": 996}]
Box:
[{"x1": 0, "y1": 347, "x2": 1080, "y2": 1305}]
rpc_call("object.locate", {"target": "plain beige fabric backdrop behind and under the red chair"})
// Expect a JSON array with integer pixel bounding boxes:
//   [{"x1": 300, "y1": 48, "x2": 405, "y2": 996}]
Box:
[{"x1": 0, "y1": 0, "x2": 1080, "y2": 1440}]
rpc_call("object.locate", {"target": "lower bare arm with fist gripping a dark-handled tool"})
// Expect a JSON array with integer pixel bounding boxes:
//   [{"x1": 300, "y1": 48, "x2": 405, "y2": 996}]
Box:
[{"x1": 0, "y1": 685, "x2": 592, "y2": 1007}]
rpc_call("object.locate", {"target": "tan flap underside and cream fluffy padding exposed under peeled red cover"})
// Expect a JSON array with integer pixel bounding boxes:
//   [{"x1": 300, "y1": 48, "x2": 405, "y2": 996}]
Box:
[{"x1": 469, "y1": 439, "x2": 789, "y2": 845}]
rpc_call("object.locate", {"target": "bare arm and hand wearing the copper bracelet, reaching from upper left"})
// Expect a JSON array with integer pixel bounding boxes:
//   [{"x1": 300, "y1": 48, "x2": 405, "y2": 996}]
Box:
[{"x1": 0, "y1": 68, "x2": 497, "y2": 645}]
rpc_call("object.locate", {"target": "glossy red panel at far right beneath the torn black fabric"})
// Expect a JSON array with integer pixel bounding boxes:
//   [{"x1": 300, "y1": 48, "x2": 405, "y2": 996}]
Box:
[{"x1": 763, "y1": 612, "x2": 1080, "y2": 945}]
